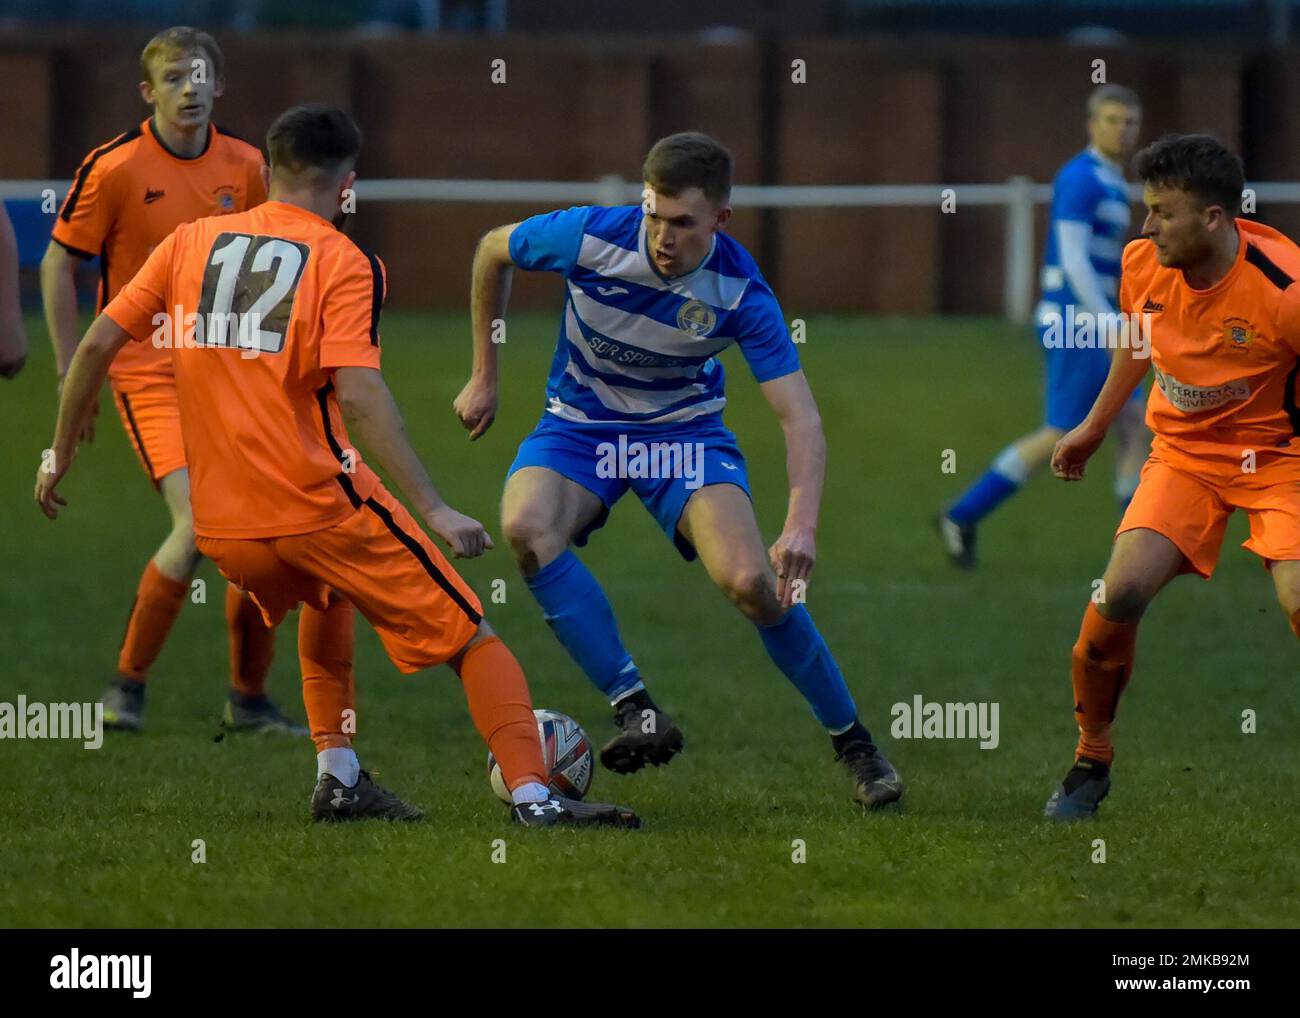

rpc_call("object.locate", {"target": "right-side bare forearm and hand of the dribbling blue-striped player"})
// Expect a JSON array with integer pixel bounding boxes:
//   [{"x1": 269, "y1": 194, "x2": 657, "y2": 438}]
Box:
[{"x1": 759, "y1": 371, "x2": 826, "y2": 607}]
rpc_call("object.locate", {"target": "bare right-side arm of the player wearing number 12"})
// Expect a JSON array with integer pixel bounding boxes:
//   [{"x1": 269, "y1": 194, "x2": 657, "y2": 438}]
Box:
[{"x1": 334, "y1": 368, "x2": 493, "y2": 558}]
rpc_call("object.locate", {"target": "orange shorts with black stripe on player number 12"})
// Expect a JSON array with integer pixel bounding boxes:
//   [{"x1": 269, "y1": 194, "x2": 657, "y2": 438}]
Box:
[{"x1": 196, "y1": 486, "x2": 482, "y2": 675}]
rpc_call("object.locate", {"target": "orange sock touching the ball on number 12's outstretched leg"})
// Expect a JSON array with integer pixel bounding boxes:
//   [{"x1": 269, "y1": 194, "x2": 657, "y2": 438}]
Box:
[{"x1": 458, "y1": 636, "x2": 547, "y2": 790}]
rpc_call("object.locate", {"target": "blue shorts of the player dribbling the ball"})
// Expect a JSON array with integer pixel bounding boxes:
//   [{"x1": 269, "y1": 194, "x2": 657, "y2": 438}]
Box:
[{"x1": 506, "y1": 413, "x2": 749, "y2": 562}]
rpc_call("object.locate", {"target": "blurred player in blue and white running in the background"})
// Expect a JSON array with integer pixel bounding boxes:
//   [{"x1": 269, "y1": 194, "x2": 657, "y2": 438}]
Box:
[{"x1": 939, "y1": 85, "x2": 1151, "y2": 569}]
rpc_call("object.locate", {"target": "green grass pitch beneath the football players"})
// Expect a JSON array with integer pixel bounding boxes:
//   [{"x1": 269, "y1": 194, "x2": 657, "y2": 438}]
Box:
[{"x1": 0, "y1": 315, "x2": 1300, "y2": 927}]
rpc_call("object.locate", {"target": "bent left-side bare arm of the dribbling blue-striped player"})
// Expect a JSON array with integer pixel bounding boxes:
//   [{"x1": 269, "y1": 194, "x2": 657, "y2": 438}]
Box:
[{"x1": 452, "y1": 222, "x2": 519, "y2": 441}]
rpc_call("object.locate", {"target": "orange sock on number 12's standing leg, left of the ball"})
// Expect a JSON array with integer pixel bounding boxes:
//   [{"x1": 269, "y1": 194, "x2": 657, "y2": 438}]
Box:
[{"x1": 298, "y1": 599, "x2": 356, "y2": 751}]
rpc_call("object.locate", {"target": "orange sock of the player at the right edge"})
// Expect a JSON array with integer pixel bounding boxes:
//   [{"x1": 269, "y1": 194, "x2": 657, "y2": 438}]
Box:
[{"x1": 1070, "y1": 603, "x2": 1138, "y2": 766}]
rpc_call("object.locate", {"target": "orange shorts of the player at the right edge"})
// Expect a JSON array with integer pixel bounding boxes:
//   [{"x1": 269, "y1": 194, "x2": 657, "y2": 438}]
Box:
[{"x1": 1115, "y1": 449, "x2": 1300, "y2": 580}]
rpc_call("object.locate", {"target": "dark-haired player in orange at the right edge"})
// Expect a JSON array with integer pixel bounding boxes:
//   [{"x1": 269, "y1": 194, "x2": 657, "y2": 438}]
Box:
[{"x1": 1045, "y1": 135, "x2": 1300, "y2": 819}]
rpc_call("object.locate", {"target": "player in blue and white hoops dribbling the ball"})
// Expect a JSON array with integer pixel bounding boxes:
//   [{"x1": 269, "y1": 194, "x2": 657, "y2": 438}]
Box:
[{"x1": 455, "y1": 133, "x2": 902, "y2": 806}]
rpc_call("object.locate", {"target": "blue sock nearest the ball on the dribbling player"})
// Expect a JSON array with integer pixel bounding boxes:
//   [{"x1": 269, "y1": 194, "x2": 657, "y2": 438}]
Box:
[{"x1": 524, "y1": 550, "x2": 641, "y2": 699}]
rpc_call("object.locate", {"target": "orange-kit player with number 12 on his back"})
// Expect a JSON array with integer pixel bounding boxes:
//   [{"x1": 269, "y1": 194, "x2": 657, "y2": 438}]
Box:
[{"x1": 36, "y1": 105, "x2": 638, "y2": 827}]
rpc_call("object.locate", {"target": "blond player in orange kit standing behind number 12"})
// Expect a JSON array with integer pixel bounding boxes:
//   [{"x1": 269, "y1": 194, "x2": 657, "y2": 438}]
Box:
[{"x1": 40, "y1": 27, "x2": 302, "y2": 732}]
